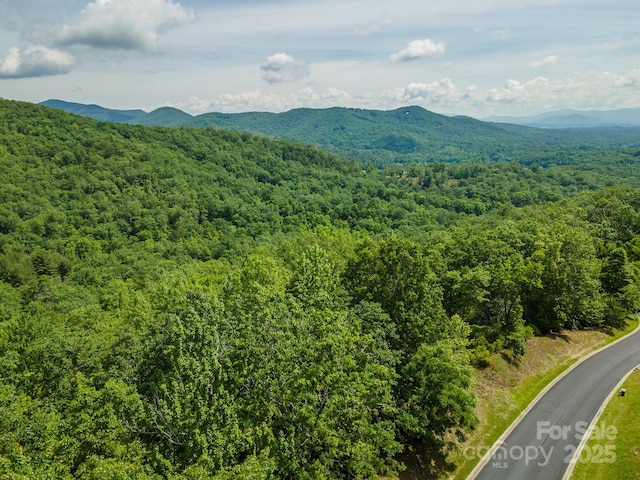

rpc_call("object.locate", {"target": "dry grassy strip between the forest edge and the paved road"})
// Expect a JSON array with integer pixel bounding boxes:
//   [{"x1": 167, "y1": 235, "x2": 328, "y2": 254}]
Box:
[{"x1": 442, "y1": 319, "x2": 640, "y2": 479}]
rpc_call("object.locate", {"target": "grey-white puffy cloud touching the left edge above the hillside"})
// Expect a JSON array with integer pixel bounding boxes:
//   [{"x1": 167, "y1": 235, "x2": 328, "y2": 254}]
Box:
[{"x1": 0, "y1": 45, "x2": 75, "y2": 78}]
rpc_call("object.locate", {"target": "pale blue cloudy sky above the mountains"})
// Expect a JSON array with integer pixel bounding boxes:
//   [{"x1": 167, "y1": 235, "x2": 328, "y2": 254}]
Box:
[{"x1": 0, "y1": 0, "x2": 640, "y2": 118}]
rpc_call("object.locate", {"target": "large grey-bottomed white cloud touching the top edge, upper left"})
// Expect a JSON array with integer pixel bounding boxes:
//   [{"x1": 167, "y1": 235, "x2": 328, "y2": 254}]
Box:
[{"x1": 58, "y1": 0, "x2": 194, "y2": 52}]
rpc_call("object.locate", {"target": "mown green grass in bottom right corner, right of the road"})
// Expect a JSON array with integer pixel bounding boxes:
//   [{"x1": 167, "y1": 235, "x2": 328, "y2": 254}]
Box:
[{"x1": 571, "y1": 371, "x2": 640, "y2": 480}]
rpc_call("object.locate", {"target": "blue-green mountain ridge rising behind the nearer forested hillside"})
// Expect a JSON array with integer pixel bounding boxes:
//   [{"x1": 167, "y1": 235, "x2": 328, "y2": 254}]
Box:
[{"x1": 42, "y1": 100, "x2": 640, "y2": 164}]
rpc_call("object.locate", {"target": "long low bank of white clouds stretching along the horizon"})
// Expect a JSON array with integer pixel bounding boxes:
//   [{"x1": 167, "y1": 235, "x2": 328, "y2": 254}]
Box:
[{"x1": 161, "y1": 65, "x2": 640, "y2": 117}]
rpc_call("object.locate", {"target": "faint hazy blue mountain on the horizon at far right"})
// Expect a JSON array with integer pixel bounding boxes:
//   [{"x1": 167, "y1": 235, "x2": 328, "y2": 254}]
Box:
[{"x1": 482, "y1": 108, "x2": 640, "y2": 128}]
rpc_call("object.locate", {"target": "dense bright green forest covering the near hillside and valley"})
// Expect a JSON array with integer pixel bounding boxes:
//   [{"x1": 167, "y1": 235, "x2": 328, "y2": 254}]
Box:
[{"x1": 0, "y1": 100, "x2": 640, "y2": 479}]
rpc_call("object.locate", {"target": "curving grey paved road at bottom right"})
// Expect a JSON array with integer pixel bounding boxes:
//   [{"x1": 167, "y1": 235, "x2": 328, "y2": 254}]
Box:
[{"x1": 469, "y1": 331, "x2": 640, "y2": 480}]
